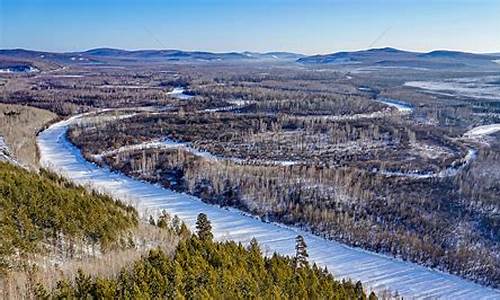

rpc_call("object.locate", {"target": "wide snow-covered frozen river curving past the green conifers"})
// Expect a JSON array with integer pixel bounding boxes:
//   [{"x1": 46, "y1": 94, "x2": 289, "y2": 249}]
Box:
[{"x1": 38, "y1": 113, "x2": 500, "y2": 299}]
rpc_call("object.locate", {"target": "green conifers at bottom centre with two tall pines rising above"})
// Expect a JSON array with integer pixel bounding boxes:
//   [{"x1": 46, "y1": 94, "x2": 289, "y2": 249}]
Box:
[{"x1": 37, "y1": 214, "x2": 377, "y2": 300}]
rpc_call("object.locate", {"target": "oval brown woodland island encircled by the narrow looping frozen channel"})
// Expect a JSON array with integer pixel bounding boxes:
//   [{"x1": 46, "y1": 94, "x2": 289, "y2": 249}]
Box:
[{"x1": 69, "y1": 113, "x2": 462, "y2": 172}]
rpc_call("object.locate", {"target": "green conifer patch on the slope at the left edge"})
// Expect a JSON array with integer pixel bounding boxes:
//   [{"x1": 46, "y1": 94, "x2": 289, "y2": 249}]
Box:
[{"x1": 0, "y1": 162, "x2": 138, "y2": 273}]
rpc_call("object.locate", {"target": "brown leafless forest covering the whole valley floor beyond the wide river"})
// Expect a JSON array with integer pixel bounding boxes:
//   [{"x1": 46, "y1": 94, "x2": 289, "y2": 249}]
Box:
[{"x1": 0, "y1": 51, "x2": 500, "y2": 287}]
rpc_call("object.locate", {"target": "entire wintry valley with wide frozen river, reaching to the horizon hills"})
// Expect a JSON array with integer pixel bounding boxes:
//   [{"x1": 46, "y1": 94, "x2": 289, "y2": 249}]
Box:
[{"x1": 0, "y1": 48, "x2": 500, "y2": 299}]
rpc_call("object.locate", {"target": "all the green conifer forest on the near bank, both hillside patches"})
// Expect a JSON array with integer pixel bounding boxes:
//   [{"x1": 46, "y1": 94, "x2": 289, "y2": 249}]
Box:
[{"x1": 0, "y1": 162, "x2": 377, "y2": 300}]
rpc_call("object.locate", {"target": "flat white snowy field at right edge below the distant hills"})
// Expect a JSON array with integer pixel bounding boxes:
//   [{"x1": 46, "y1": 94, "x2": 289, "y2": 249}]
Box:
[{"x1": 404, "y1": 76, "x2": 500, "y2": 100}]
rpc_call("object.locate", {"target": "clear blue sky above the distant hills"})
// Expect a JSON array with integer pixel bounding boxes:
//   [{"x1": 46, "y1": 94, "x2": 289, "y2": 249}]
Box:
[{"x1": 0, "y1": 0, "x2": 500, "y2": 54}]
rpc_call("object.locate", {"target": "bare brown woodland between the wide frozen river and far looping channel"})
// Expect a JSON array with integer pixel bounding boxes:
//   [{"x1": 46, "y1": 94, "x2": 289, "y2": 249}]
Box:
[{"x1": 68, "y1": 108, "x2": 500, "y2": 284}]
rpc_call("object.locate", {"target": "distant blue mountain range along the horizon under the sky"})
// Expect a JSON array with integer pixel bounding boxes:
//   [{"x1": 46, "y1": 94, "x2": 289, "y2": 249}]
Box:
[{"x1": 0, "y1": 48, "x2": 500, "y2": 69}]
